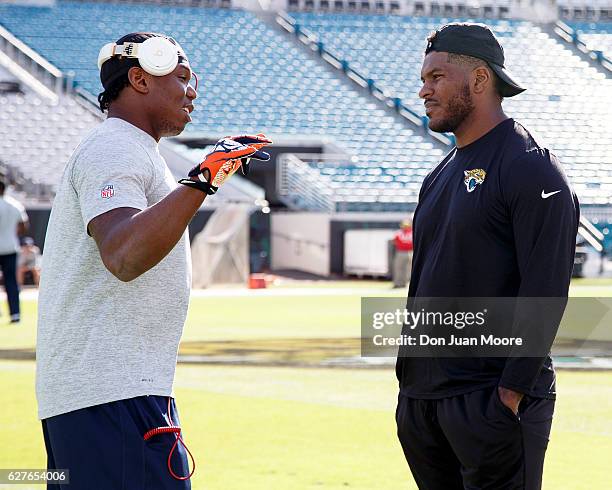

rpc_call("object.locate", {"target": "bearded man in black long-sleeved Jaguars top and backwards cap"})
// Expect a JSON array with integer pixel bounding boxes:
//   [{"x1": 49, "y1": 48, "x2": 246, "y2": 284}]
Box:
[{"x1": 396, "y1": 24, "x2": 579, "y2": 490}]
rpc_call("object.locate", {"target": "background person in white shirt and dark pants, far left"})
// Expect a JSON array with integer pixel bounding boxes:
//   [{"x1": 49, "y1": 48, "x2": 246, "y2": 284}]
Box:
[{"x1": 0, "y1": 177, "x2": 28, "y2": 323}]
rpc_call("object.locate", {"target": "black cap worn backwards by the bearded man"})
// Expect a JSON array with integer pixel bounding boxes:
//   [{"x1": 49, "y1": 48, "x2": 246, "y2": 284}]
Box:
[{"x1": 425, "y1": 22, "x2": 525, "y2": 97}]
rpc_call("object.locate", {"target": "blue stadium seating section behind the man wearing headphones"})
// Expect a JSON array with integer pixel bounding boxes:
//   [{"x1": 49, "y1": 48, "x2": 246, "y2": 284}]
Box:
[{"x1": 0, "y1": 1, "x2": 450, "y2": 210}]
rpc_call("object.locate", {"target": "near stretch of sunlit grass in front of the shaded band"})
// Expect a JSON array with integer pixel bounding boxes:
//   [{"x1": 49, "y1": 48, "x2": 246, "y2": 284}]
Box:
[{"x1": 0, "y1": 361, "x2": 612, "y2": 490}]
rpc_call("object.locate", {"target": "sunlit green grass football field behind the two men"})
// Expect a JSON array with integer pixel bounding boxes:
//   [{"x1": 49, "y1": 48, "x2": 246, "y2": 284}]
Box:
[{"x1": 0, "y1": 281, "x2": 612, "y2": 490}]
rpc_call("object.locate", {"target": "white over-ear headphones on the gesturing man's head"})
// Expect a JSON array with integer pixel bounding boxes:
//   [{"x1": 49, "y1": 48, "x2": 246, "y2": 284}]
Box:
[{"x1": 98, "y1": 36, "x2": 186, "y2": 77}]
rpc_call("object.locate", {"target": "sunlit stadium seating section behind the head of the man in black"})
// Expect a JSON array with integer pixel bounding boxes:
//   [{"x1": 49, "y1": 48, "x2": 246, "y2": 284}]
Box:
[{"x1": 291, "y1": 13, "x2": 612, "y2": 204}]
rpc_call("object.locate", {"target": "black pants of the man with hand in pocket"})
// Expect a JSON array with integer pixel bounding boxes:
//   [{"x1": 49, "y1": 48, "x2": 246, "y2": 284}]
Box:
[{"x1": 395, "y1": 387, "x2": 555, "y2": 490}]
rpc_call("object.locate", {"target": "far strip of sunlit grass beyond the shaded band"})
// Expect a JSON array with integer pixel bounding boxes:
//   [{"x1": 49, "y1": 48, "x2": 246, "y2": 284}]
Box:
[{"x1": 0, "y1": 279, "x2": 612, "y2": 349}]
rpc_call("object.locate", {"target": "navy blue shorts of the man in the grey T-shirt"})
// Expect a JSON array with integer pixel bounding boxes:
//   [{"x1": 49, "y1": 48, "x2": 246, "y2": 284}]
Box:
[{"x1": 42, "y1": 396, "x2": 191, "y2": 490}]
